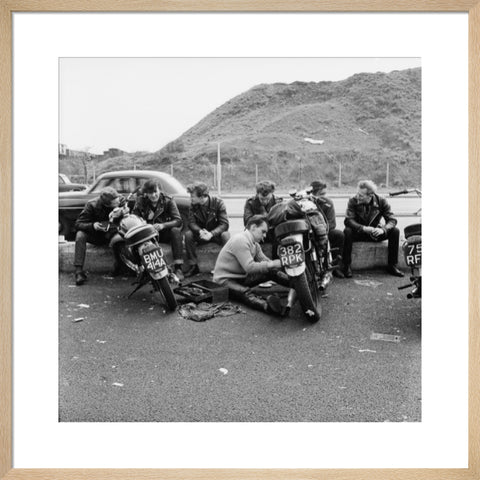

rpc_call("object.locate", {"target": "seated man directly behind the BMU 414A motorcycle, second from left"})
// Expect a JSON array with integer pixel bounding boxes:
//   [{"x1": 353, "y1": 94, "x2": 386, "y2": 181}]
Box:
[{"x1": 132, "y1": 179, "x2": 184, "y2": 280}]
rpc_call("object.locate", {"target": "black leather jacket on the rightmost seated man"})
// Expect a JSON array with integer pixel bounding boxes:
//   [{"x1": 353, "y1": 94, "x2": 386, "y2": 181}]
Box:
[{"x1": 344, "y1": 194, "x2": 397, "y2": 233}]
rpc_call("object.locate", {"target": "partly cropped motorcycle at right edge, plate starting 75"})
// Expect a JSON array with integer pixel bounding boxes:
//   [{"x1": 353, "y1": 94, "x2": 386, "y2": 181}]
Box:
[{"x1": 390, "y1": 188, "x2": 422, "y2": 298}]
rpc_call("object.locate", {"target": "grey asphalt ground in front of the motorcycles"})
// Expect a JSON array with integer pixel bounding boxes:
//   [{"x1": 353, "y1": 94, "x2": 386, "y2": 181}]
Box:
[{"x1": 59, "y1": 272, "x2": 421, "y2": 422}]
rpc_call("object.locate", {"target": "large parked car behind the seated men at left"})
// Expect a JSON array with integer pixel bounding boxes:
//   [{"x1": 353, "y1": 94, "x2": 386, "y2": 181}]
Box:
[{"x1": 58, "y1": 170, "x2": 190, "y2": 240}]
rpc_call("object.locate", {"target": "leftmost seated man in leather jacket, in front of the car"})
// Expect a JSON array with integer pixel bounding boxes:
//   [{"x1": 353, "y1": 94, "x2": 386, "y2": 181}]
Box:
[{"x1": 73, "y1": 187, "x2": 123, "y2": 285}]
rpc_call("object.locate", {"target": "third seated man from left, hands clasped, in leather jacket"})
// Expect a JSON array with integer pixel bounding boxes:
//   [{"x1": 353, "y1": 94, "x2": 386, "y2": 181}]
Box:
[{"x1": 185, "y1": 182, "x2": 230, "y2": 277}]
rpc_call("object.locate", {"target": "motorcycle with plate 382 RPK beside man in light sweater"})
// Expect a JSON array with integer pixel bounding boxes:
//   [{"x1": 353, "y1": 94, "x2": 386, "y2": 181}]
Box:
[{"x1": 269, "y1": 189, "x2": 333, "y2": 323}]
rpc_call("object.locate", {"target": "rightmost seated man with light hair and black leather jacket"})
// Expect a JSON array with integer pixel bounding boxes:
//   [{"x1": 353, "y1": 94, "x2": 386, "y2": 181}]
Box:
[{"x1": 343, "y1": 180, "x2": 403, "y2": 278}]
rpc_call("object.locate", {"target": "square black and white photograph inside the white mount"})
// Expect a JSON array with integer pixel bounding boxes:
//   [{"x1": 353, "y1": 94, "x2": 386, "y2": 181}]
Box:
[{"x1": 58, "y1": 57, "x2": 427, "y2": 423}]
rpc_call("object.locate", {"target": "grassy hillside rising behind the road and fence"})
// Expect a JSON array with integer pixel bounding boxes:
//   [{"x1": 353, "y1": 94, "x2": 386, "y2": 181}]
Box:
[{"x1": 62, "y1": 68, "x2": 421, "y2": 191}]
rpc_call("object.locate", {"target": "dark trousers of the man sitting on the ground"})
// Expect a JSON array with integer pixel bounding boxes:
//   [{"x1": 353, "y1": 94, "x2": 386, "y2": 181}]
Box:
[{"x1": 221, "y1": 270, "x2": 290, "y2": 311}]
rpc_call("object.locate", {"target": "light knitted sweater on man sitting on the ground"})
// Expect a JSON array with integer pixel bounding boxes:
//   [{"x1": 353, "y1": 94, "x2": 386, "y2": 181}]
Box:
[{"x1": 213, "y1": 230, "x2": 271, "y2": 283}]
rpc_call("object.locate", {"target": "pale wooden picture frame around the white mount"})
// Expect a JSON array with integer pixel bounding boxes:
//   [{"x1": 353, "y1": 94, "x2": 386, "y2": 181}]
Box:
[{"x1": 0, "y1": 0, "x2": 480, "y2": 480}]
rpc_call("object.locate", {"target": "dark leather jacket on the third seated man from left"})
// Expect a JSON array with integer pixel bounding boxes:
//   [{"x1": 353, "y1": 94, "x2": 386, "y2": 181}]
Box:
[{"x1": 188, "y1": 195, "x2": 229, "y2": 237}]
